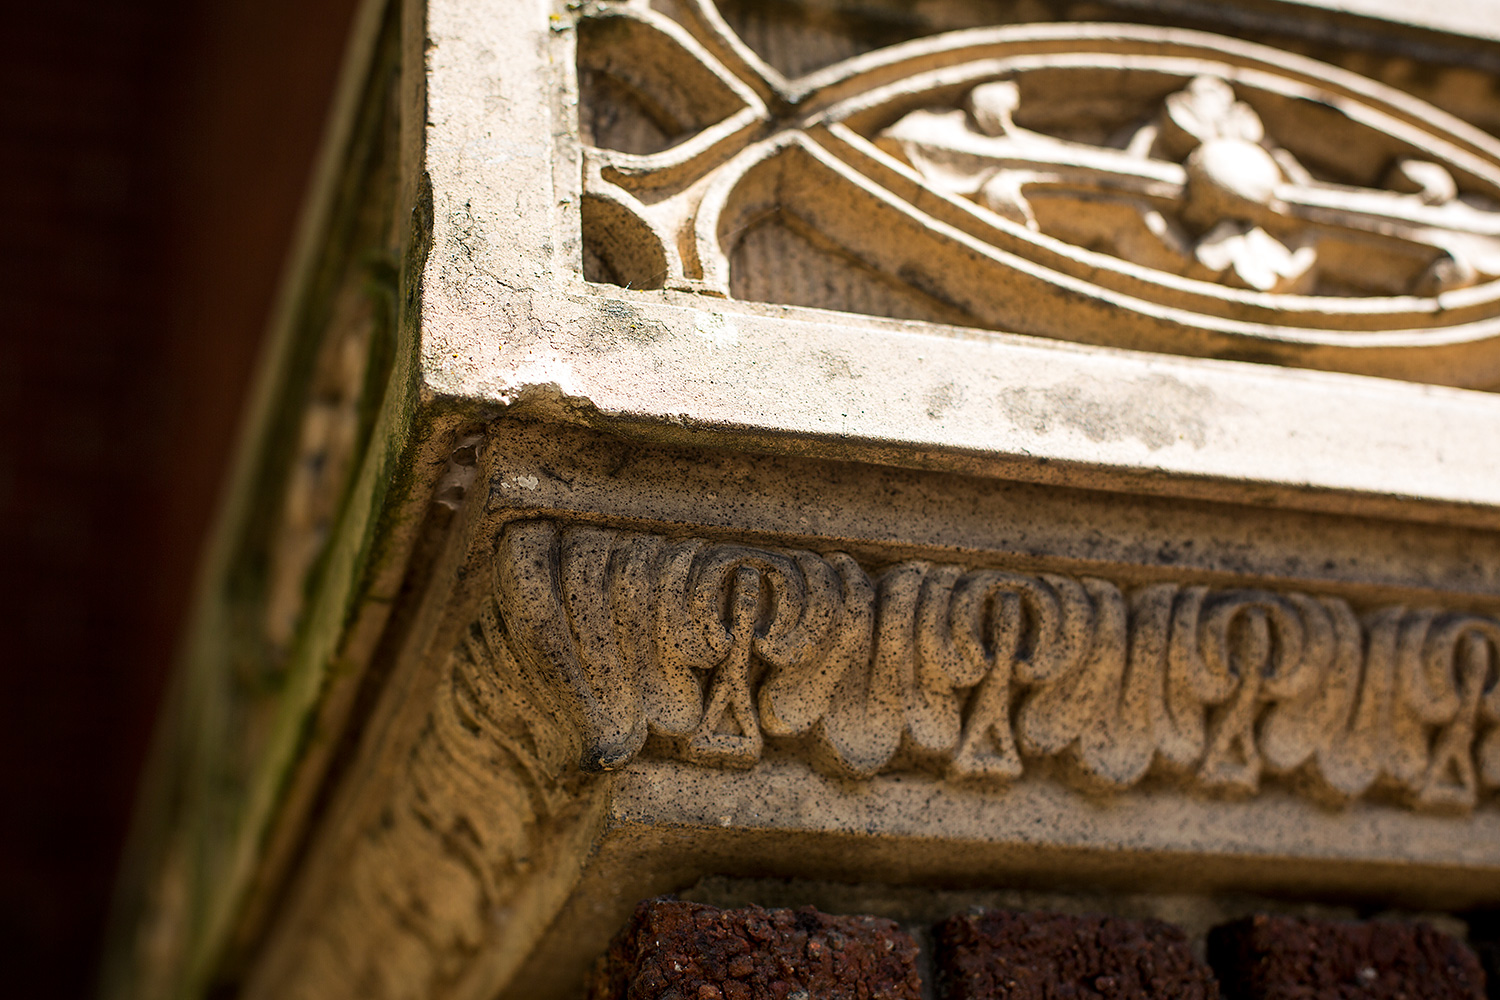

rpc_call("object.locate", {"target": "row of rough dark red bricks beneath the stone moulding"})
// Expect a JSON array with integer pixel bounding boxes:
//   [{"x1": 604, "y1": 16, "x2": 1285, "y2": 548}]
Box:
[{"x1": 590, "y1": 898, "x2": 1485, "y2": 1000}]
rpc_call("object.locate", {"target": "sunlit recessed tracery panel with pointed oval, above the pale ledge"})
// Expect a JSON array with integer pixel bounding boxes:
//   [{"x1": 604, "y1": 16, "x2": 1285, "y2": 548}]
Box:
[{"x1": 578, "y1": 0, "x2": 1500, "y2": 387}]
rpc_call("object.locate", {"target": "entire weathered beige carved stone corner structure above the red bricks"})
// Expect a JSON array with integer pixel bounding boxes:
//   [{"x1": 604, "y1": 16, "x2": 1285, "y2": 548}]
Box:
[{"x1": 108, "y1": 0, "x2": 1500, "y2": 1000}]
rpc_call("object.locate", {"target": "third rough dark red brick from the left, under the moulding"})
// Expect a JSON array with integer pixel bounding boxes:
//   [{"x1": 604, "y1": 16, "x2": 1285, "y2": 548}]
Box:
[{"x1": 1209, "y1": 915, "x2": 1485, "y2": 1000}]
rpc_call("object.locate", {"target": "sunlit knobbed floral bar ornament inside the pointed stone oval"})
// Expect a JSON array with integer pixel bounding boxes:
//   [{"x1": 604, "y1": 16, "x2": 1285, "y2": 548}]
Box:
[{"x1": 879, "y1": 75, "x2": 1500, "y2": 295}]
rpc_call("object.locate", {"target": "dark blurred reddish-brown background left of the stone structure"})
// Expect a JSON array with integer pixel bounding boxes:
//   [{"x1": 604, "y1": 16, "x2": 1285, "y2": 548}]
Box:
[{"x1": 0, "y1": 0, "x2": 354, "y2": 999}]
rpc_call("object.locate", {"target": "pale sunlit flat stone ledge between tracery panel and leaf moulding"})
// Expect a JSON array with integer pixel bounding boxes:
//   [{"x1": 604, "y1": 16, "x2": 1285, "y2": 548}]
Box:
[{"x1": 428, "y1": 283, "x2": 1500, "y2": 526}]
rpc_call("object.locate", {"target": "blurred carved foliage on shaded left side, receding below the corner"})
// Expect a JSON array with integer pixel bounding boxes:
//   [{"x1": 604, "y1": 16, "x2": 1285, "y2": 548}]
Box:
[{"x1": 246, "y1": 587, "x2": 596, "y2": 1000}]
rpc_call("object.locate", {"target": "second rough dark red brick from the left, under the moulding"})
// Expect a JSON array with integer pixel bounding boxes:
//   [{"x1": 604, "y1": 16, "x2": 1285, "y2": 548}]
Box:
[{"x1": 936, "y1": 912, "x2": 1218, "y2": 1000}]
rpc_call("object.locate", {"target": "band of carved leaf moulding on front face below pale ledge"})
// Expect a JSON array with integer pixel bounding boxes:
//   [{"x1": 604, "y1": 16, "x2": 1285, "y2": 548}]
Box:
[{"x1": 495, "y1": 520, "x2": 1500, "y2": 810}]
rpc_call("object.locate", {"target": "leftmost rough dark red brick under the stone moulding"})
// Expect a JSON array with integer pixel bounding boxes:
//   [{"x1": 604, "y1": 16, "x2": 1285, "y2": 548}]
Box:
[{"x1": 590, "y1": 900, "x2": 921, "y2": 1000}]
